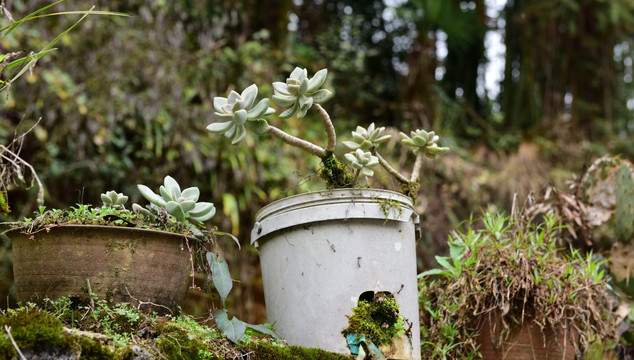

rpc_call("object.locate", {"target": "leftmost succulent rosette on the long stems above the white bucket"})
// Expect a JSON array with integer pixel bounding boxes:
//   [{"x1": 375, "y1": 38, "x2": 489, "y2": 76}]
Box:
[{"x1": 207, "y1": 84, "x2": 275, "y2": 144}]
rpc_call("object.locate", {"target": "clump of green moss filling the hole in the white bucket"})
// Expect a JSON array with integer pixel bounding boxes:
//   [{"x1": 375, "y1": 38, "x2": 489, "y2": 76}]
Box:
[{"x1": 342, "y1": 292, "x2": 404, "y2": 346}]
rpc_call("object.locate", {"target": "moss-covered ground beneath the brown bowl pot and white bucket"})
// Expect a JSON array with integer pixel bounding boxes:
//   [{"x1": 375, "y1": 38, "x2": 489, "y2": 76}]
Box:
[{"x1": 0, "y1": 299, "x2": 347, "y2": 360}]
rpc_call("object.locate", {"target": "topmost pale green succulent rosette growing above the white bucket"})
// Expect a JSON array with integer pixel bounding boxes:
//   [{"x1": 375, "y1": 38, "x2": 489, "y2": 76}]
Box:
[{"x1": 272, "y1": 67, "x2": 332, "y2": 119}]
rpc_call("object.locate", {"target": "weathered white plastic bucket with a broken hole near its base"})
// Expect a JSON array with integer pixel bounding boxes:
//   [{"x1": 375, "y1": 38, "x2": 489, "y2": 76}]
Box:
[{"x1": 251, "y1": 189, "x2": 420, "y2": 359}]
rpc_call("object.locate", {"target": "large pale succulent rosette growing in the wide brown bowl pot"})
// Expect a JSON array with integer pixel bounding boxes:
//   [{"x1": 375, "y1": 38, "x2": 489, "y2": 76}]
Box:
[{"x1": 134, "y1": 175, "x2": 216, "y2": 222}]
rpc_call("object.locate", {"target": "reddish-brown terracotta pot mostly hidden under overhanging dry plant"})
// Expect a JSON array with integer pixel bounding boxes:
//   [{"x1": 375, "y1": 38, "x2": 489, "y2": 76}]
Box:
[{"x1": 476, "y1": 314, "x2": 575, "y2": 360}]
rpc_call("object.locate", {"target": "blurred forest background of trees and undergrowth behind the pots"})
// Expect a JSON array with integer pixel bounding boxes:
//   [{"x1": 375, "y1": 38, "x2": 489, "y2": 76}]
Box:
[{"x1": 0, "y1": 0, "x2": 634, "y2": 322}]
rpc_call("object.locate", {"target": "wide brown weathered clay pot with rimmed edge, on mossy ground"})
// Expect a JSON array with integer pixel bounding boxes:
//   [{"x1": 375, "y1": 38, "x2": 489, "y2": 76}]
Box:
[{"x1": 7, "y1": 225, "x2": 196, "y2": 313}]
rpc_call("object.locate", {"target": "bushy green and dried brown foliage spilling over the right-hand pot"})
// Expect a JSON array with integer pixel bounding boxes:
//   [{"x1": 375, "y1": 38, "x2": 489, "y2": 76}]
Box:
[{"x1": 419, "y1": 210, "x2": 615, "y2": 359}]
